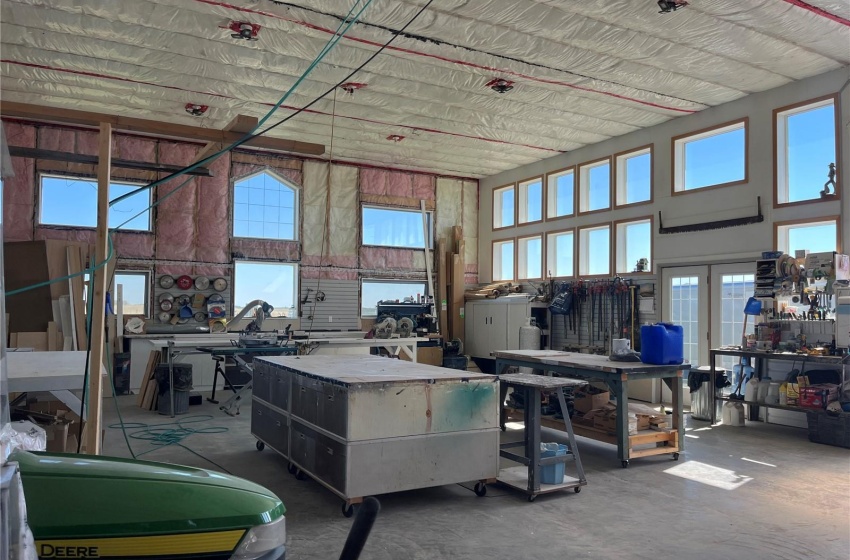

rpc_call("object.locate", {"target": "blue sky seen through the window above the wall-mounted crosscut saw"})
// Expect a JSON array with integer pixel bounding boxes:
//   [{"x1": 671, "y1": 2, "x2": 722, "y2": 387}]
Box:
[{"x1": 682, "y1": 124, "x2": 745, "y2": 190}]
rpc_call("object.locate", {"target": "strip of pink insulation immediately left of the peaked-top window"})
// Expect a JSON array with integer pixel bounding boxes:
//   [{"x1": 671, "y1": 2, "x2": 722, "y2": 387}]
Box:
[{"x1": 195, "y1": 154, "x2": 230, "y2": 262}]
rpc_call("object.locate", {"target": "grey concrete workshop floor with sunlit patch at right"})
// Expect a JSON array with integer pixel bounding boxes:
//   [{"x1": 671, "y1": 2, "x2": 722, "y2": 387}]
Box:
[{"x1": 104, "y1": 396, "x2": 850, "y2": 560}]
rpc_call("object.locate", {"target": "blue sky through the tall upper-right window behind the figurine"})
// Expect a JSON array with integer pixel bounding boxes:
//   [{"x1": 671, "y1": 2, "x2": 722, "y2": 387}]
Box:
[{"x1": 786, "y1": 105, "x2": 837, "y2": 202}]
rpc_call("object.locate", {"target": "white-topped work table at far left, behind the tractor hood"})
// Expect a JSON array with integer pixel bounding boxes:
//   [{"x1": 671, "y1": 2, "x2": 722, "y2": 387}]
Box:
[{"x1": 6, "y1": 351, "x2": 107, "y2": 414}]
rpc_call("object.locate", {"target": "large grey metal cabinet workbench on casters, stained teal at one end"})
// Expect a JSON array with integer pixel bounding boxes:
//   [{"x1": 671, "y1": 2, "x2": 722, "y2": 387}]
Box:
[{"x1": 251, "y1": 355, "x2": 500, "y2": 516}]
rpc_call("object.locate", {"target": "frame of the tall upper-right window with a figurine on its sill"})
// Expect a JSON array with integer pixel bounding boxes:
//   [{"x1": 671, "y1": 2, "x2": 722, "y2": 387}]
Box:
[{"x1": 774, "y1": 95, "x2": 841, "y2": 205}]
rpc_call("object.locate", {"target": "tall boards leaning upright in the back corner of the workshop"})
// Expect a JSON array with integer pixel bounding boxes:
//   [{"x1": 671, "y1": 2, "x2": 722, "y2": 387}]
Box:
[{"x1": 437, "y1": 226, "x2": 466, "y2": 341}]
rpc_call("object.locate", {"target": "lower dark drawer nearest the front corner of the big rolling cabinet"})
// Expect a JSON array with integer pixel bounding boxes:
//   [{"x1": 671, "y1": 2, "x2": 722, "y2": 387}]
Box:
[{"x1": 292, "y1": 420, "x2": 346, "y2": 494}]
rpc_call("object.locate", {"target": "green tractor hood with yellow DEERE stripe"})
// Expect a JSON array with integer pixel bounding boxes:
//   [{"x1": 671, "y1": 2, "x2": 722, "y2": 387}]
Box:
[{"x1": 9, "y1": 451, "x2": 285, "y2": 558}]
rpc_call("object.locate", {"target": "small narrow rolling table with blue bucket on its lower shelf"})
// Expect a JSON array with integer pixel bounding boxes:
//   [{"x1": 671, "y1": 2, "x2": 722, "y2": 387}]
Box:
[{"x1": 496, "y1": 373, "x2": 587, "y2": 502}]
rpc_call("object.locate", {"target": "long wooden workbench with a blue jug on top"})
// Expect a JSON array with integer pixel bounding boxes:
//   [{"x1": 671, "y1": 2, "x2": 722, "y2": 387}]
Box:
[{"x1": 493, "y1": 350, "x2": 691, "y2": 468}]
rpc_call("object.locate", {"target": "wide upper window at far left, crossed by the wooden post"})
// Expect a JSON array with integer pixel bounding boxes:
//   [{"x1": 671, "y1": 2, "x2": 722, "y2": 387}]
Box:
[{"x1": 39, "y1": 175, "x2": 151, "y2": 231}]
